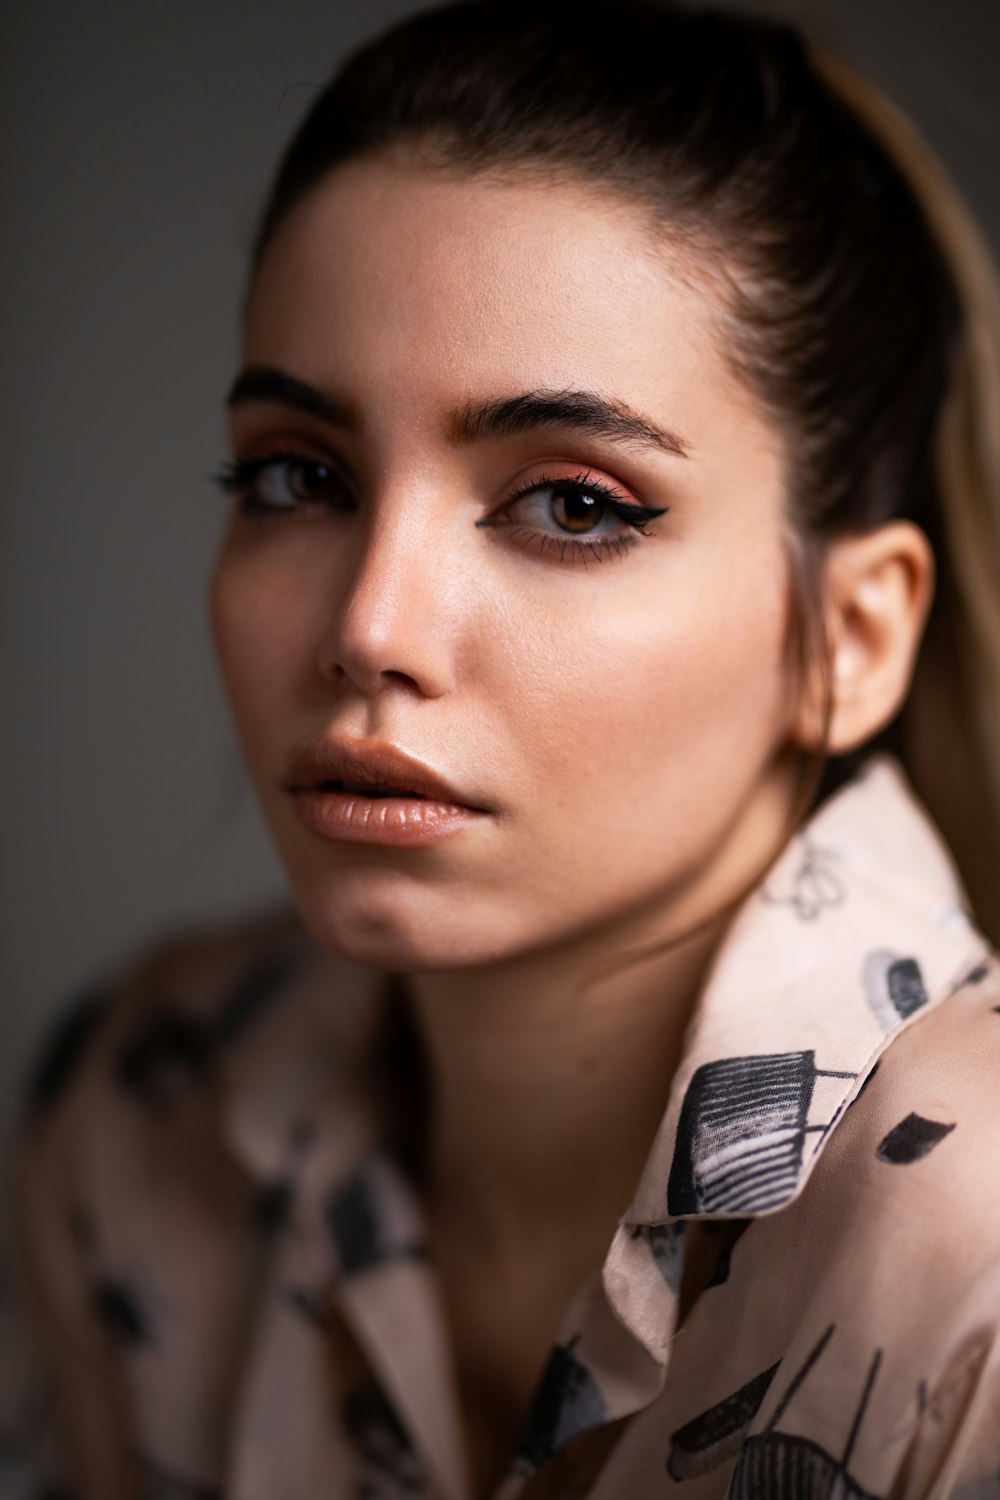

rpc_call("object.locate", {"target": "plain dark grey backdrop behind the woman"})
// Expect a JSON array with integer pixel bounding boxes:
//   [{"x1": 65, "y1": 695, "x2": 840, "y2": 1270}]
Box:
[{"x1": 0, "y1": 0, "x2": 1000, "y2": 1130}]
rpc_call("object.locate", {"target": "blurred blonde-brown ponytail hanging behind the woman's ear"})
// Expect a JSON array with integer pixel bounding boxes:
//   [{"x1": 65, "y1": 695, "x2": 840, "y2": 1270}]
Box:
[{"x1": 817, "y1": 57, "x2": 1000, "y2": 942}]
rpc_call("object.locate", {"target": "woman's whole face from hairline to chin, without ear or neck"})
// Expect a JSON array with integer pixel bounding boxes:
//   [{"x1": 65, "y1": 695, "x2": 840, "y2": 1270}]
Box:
[{"x1": 211, "y1": 159, "x2": 792, "y2": 971}]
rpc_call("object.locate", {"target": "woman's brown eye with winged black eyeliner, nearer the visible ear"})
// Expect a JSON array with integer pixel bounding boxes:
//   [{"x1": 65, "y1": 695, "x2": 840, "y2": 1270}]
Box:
[{"x1": 477, "y1": 474, "x2": 667, "y2": 561}]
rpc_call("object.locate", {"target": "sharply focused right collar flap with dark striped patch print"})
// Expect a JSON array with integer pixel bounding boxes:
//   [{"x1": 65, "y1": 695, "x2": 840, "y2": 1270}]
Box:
[{"x1": 625, "y1": 756, "x2": 987, "y2": 1226}]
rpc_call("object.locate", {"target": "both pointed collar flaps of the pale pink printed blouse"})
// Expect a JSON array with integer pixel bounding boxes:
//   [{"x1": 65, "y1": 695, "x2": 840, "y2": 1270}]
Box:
[{"x1": 220, "y1": 756, "x2": 987, "y2": 1226}]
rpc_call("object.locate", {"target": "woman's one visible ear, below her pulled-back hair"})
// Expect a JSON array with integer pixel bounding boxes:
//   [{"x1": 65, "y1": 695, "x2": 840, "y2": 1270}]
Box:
[{"x1": 793, "y1": 521, "x2": 934, "y2": 755}]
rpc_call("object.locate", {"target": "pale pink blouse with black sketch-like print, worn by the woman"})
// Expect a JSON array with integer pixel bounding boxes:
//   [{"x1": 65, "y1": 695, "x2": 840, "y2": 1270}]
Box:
[{"x1": 0, "y1": 756, "x2": 1000, "y2": 1500}]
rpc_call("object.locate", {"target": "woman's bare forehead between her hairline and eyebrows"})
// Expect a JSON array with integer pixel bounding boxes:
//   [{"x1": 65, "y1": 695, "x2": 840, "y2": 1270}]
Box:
[{"x1": 244, "y1": 159, "x2": 759, "y2": 444}]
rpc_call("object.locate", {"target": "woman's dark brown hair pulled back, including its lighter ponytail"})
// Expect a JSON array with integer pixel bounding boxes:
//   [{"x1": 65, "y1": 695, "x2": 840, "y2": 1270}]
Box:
[{"x1": 253, "y1": 0, "x2": 1000, "y2": 938}]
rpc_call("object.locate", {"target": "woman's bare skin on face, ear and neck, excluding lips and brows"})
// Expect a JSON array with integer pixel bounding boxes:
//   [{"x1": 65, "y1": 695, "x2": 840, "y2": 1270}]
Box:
[{"x1": 211, "y1": 156, "x2": 931, "y2": 1494}]
